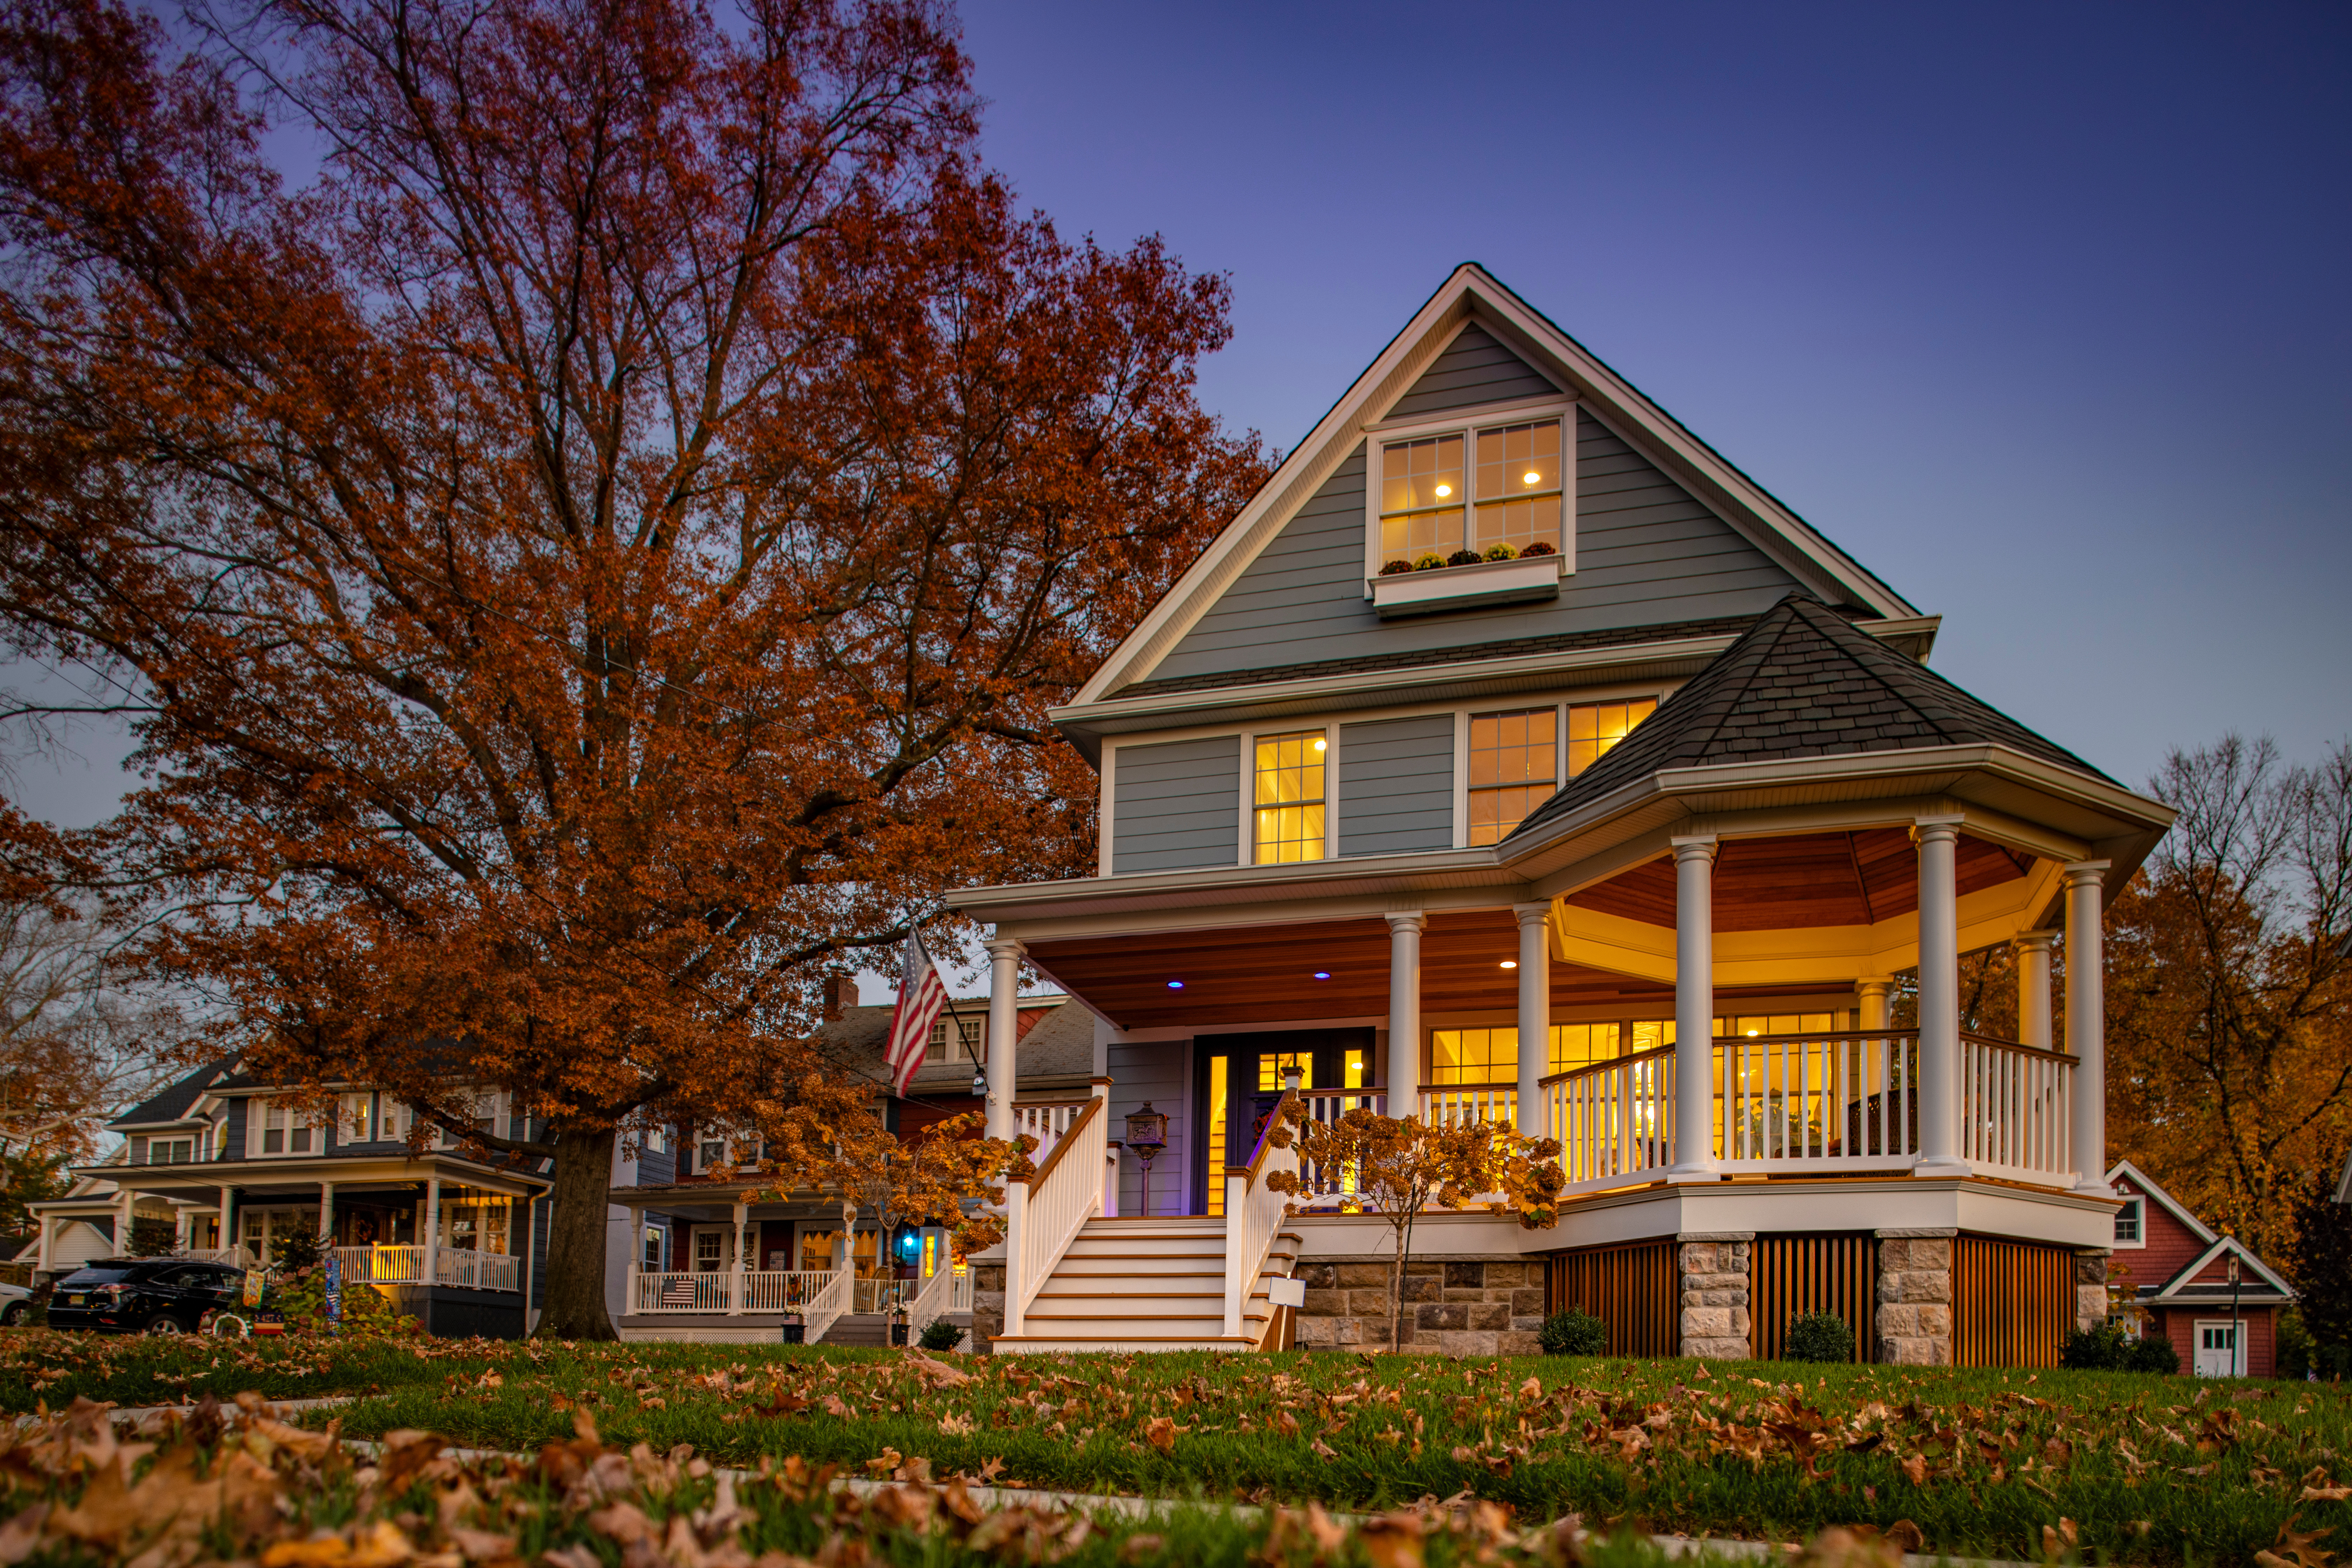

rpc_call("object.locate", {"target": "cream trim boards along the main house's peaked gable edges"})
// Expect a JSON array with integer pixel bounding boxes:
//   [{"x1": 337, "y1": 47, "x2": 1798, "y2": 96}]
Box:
[{"x1": 1072, "y1": 263, "x2": 1917, "y2": 708}]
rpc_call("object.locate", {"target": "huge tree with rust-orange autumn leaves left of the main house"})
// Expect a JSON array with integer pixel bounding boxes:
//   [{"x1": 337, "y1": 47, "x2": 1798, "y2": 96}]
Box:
[{"x1": 0, "y1": 0, "x2": 1263, "y2": 1335}]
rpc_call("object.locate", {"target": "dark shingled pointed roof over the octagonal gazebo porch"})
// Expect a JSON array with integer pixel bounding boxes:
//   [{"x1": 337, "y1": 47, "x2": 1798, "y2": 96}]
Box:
[{"x1": 1512, "y1": 593, "x2": 2114, "y2": 837}]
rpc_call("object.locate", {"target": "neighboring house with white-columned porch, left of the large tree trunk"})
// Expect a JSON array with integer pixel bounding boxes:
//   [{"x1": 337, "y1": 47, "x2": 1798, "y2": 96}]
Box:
[{"x1": 30, "y1": 1058, "x2": 548, "y2": 1338}]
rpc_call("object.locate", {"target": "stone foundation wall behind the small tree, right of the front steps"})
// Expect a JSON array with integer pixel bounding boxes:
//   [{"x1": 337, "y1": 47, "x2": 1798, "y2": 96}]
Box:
[{"x1": 1294, "y1": 1258, "x2": 1543, "y2": 1357}]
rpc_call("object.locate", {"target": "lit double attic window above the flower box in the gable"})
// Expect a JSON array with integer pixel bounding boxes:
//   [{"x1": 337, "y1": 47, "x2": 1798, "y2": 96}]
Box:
[{"x1": 1378, "y1": 419, "x2": 1567, "y2": 567}]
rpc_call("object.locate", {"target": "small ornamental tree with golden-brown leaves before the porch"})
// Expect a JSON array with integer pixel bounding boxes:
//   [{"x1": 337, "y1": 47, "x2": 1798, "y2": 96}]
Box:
[{"x1": 1265, "y1": 1098, "x2": 1567, "y2": 1349}]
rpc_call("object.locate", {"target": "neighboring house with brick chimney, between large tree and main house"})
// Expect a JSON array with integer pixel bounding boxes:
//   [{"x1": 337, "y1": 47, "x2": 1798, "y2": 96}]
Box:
[{"x1": 609, "y1": 978, "x2": 1094, "y2": 1345}]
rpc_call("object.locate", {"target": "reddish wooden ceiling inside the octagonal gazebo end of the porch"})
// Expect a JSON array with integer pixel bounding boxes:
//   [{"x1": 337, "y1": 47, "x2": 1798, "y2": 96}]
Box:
[{"x1": 1567, "y1": 827, "x2": 2032, "y2": 931}]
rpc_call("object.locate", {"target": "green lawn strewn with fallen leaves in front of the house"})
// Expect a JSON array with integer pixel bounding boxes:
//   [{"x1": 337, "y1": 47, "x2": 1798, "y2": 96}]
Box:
[{"x1": 0, "y1": 1335, "x2": 2352, "y2": 1568}]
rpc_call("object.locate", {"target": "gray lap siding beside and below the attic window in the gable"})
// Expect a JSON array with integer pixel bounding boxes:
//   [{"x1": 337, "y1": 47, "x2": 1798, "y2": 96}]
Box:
[{"x1": 1150, "y1": 395, "x2": 1797, "y2": 679}]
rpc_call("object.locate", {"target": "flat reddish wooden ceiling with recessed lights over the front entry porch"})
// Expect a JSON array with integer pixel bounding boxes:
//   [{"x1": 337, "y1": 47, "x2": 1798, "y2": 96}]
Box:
[{"x1": 1030, "y1": 910, "x2": 1773, "y2": 1030}]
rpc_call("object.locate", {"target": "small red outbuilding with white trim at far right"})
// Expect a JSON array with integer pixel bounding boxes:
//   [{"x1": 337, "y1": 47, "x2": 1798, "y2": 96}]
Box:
[{"x1": 2107, "y1": 1159, "x2": 2296, "y2": 1378}]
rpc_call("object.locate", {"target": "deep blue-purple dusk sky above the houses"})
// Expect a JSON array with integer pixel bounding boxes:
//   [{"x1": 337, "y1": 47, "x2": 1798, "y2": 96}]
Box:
[{"x1": 21, "y1": 0, "x2": 2352, "y2": 846}]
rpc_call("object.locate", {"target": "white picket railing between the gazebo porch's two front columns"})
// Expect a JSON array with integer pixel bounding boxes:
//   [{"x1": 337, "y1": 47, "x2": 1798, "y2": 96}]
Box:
[{"x1": 1710, "y1": 1030, "x2": 1919, "y2": 1173}]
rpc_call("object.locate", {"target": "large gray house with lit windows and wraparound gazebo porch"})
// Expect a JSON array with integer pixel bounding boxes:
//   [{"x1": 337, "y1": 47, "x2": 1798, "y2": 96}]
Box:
[{"x1": 936, "y1": 266, "x2": 2171, "y2": 1364}]
